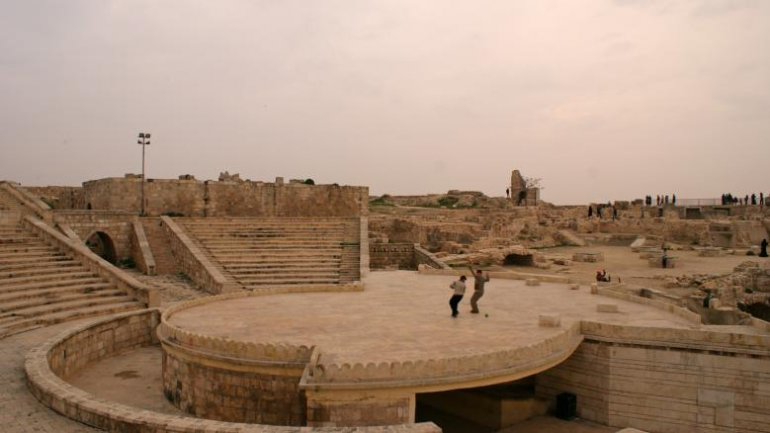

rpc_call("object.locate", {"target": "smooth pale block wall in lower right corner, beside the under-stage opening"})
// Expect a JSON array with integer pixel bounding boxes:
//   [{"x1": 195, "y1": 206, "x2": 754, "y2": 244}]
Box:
[{"x1": 536, "y1": 337, "x2": 770, "y2": 433}]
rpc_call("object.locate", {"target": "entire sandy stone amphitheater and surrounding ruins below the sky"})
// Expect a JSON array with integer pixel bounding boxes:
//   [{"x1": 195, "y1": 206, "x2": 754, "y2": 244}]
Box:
[{"x1": 0, "y1": 176, "x2": 770, "y2": 433}]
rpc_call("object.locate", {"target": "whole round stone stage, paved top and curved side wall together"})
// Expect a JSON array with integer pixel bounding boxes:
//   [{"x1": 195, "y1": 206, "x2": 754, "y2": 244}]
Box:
[{"x1": 158, "y1": 271, "x2": 699, "y2": 426}]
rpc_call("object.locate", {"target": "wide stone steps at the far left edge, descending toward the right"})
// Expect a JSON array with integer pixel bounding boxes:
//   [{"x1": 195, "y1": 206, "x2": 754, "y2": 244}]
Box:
[{"x1": 0, "y1": 222, "x2": 144, "y2": 338}]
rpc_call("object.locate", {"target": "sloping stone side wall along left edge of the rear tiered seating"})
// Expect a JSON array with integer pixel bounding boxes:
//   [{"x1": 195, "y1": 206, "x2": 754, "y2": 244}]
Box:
[{"x1": 161, "y1": 216, "x2": 240, "y2": 294}]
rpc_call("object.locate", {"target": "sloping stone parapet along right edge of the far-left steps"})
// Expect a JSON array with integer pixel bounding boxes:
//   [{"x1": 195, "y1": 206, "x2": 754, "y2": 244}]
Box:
[{"x1": 23, "y1": 216, "x2": 160, "y2": 308}]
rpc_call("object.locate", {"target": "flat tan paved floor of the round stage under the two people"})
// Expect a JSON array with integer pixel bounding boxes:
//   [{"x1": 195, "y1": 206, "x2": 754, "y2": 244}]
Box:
[{"x1": 170, "y1": 271, "x2": 698, "y2": 365}]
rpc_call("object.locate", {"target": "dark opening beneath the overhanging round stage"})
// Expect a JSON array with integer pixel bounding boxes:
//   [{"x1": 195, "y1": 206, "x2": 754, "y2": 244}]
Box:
[{"x1": 415, "y1": 376, "x2": 548, "y2": 433}]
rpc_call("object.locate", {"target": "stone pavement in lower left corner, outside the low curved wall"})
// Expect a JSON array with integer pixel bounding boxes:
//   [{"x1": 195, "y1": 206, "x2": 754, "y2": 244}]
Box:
[{"x1": 0, "y1": 319, "x2": 101, "y2": 433}]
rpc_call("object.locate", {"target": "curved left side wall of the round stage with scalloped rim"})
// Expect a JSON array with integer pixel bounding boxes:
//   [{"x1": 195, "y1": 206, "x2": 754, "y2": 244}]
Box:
[{"x1": 158, "y1": 295, "x2": 313, "y2": 426}]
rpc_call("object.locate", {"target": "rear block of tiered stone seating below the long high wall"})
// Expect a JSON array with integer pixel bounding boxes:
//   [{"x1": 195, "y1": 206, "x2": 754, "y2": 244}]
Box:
[{"x1": 178, "y1": 218, "x2": 350, "y2": 289}]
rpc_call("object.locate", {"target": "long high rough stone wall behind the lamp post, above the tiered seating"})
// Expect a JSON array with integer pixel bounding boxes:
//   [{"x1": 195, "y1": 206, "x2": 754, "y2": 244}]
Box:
[{"x1": 83, "y1": 177, "x2": 369, "y2": 217}]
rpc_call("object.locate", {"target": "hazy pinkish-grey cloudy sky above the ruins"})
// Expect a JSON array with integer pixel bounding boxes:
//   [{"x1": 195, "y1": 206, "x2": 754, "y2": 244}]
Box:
[{"x1": 0, "y1": 0, "x2": 770, "y2": 204}]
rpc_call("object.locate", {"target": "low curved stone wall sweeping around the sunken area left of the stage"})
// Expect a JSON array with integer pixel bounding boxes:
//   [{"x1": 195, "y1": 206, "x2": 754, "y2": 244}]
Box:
[{"x1": 24, "y1": 309, "x2": 441, "y2": 433}]
